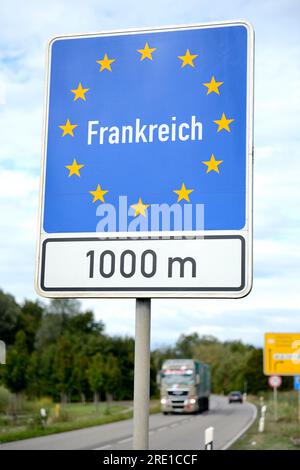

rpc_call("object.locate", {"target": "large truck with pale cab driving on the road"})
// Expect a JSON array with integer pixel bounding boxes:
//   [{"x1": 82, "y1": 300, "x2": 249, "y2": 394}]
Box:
[{"x1": 158, "y1": 359, "x2": 210, "y2": 415}]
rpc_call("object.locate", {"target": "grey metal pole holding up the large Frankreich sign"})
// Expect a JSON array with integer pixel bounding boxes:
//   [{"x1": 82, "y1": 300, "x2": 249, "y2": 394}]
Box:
[{"x1": 133, "y1": 299, "x2": 151, "y2": 450}]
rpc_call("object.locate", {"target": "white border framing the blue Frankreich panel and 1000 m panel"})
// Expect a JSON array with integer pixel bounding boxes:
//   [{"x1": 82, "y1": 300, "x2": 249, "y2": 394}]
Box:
[{"x1": 35, "y1": 20, "x2": 254, "y2": 298}]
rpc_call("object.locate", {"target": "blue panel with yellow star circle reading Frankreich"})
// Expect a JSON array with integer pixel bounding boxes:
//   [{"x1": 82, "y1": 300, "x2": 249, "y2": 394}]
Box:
[{"x1": 43, "y1": 24, "x2": 249, "y2": 233}]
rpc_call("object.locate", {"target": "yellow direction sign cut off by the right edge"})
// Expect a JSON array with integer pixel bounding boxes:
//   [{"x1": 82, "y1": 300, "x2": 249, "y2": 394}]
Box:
[{"x1": 264, "y1": 333, "x2": 300, "y2": 375}]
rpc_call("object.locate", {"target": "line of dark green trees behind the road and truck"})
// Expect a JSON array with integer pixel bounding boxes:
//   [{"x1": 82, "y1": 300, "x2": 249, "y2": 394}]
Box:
[{"x1": 0, "y1": 290, "x2": 292, "y2": 403}]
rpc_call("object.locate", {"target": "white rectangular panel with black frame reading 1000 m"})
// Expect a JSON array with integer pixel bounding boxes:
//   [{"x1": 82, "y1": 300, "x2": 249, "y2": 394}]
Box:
[{"x1": 42, "y1": 236, "x2": 245, "y2": 297}]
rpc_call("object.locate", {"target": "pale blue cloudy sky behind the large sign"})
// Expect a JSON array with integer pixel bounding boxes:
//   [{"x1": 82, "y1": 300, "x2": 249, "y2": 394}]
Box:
[{"x1": 0, "y1": 0, "x2": 300, "y2": 347}]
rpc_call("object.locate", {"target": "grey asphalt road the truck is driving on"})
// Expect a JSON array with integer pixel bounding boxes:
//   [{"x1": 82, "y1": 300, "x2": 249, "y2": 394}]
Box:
[{"x1": 0, "y1": 396, "x2": 256, "y2": 450}]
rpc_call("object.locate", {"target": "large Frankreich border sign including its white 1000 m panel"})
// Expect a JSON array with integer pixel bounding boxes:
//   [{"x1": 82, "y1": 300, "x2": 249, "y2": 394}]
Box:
[{"x1": 36, "y1": 22, "x2": 253, "y2": 297}]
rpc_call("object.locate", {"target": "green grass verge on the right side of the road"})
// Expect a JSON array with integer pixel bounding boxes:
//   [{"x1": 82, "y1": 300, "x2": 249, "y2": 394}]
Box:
[{"x1": 230, "y1": 392, "x2": 300, "y2": 450}]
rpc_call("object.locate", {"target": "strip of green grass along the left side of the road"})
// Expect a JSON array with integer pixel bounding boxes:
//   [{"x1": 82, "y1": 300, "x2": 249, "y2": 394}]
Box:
[{"x1": 0, "y1": 401, "x2": 160, "y2": 443}]
